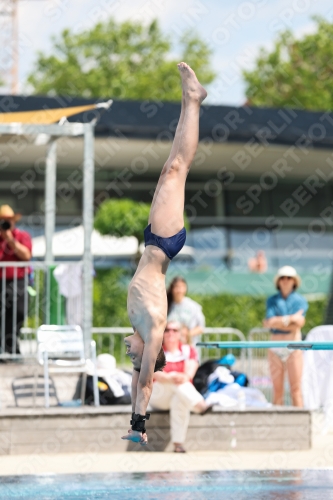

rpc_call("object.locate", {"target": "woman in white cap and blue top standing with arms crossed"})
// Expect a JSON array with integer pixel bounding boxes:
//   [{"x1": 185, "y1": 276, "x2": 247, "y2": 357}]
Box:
[{"x1": 263, "y1": 266, "x2": 309, "y2": 407}]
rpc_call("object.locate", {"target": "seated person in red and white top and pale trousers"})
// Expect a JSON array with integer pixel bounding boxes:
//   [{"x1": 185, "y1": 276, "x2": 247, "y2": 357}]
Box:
[{"x1": 150, "y1": 321, "x2": 210, "y2": 453}]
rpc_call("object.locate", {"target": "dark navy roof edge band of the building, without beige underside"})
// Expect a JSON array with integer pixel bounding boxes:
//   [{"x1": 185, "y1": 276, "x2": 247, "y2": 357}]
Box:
[{"x1": 0, "y1": 95, "x2": 333, "y2": 148}]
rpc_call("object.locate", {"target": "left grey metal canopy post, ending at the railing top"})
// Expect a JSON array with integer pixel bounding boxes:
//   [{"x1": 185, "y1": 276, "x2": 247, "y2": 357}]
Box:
[{"x1": 45, "y1": 139, "x2": 57, "y2": 262}]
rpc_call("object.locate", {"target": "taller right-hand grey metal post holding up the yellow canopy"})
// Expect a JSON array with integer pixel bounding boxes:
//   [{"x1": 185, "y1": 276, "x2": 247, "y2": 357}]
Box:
[{"x1": 82, "y1": 123, "x2": 95, "y2": 357}]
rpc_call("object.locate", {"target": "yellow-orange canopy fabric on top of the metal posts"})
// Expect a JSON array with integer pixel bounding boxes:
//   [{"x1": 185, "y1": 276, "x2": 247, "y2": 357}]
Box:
[{"x1": 0, "y1": 104, "x2": 98, "y2": 125}]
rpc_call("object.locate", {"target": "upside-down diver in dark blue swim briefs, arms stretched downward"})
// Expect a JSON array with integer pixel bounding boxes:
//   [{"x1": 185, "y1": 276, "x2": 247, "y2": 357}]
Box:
[{"x1": 122, "y1": 62, "x2": 207, "y2": 445}]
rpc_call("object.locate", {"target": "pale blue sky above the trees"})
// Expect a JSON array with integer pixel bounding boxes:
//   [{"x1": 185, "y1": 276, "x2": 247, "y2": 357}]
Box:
[{"x1": 9, "y1": 0, "x2": 333, "y2": 105}]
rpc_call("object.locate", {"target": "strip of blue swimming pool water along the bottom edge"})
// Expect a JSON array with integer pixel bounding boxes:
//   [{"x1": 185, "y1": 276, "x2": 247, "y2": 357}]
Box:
[{"x1": 0, "y1": 470, "x2": 333, "y2": 500}]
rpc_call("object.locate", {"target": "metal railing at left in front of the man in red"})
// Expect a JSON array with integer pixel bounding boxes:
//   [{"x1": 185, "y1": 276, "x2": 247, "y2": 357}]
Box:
[{"x1": 0, "y1": 261, "x2": 83, "y2": 359}]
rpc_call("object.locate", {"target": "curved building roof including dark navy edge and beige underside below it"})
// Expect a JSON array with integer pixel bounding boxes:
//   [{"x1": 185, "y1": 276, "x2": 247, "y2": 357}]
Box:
[{"x1": 0, "y1": 96, "x2": 333, "y2": 180}]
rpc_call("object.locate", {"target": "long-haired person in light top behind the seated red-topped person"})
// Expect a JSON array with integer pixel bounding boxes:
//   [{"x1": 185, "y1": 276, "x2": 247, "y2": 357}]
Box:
[{"x1": 167, "y1": 276, "x2": 205, "y2": 345}]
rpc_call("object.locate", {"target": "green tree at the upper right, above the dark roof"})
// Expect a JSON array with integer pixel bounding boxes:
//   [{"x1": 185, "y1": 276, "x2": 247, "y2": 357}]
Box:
[{"x1": 243, "y1": 17, "x2": 333, "y2": 111}]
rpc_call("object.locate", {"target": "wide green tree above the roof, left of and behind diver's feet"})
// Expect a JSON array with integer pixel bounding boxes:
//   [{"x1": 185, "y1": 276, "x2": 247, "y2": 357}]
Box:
[{"x1": 28, "y1": 19, "x2": 215, "y2": 101}]
